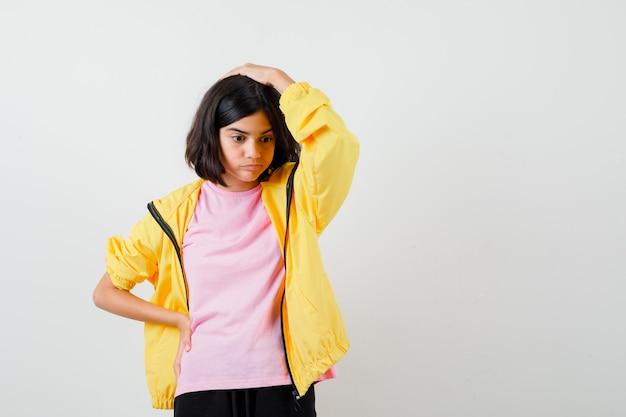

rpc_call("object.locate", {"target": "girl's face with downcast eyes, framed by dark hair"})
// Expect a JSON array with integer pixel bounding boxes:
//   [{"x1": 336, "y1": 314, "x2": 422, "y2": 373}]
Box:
[{"x1": 220, "y1": 111, "x2": 276, "y2": 191}]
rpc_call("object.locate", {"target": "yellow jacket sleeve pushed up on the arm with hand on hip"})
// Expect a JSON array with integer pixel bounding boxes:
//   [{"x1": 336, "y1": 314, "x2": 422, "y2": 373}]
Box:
[{"x1": 105, "y1": 214, "x2": 158, "y2": 290}]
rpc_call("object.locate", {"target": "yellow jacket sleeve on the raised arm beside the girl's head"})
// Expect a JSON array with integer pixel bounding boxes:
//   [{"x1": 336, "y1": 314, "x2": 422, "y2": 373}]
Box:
[{"x1": 280, "y1": 82, "x2": 359, "y2": 234}]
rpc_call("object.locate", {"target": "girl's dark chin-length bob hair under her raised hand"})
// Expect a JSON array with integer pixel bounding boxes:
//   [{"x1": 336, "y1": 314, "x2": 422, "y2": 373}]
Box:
[{"x1": 185, "y1": 75, "x2": 300, "y2": 186}]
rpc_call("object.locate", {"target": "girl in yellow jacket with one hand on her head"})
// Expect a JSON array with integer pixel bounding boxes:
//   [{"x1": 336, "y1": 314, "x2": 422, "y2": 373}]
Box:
[{"x1": 93, "y1": 64, "x2": 359, "y2": 417}]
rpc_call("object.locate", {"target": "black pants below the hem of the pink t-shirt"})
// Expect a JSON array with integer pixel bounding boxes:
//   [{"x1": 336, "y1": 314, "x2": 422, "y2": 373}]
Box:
[{"x1": 174, "y1": 386, "x2": 317, "y2": 417}]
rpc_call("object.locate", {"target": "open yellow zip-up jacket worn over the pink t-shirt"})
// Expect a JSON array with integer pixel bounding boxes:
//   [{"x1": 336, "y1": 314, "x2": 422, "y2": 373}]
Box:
[{"x1": 106, "y1": 82, "x2": 359, "y2": 409}]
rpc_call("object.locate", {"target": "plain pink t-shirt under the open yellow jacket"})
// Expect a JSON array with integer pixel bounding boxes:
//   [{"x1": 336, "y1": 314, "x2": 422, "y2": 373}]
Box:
[{"x1": 176, "y1": 181, "x2": 291, "y2": 395}]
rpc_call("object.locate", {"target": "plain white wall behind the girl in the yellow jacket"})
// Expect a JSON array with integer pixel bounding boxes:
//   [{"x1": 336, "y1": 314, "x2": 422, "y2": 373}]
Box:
[{"x1": 0, "y1": 0, "x2": 626, "y2": 417}]
